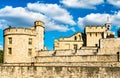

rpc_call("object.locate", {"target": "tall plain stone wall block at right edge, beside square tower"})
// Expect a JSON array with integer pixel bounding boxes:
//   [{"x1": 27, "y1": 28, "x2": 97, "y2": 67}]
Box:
[{"x1": 98, "y1": 38, "x2": 120, "y2": 54}]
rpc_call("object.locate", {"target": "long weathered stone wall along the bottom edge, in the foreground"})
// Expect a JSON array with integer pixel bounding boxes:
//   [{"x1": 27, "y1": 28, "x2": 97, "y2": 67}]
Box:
[{"x1": 0, "y1": 65, "x2": 120, "y2": 78}]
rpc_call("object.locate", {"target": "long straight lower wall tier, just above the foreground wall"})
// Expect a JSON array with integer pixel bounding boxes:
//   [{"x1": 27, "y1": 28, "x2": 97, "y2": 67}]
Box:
[{"x1": 36, "y1": 55, "x2": 118, "y2": 63}]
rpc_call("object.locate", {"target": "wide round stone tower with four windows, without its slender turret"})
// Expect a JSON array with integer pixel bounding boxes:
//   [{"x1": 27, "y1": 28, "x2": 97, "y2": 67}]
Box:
[{"x1": 4, "y1": 27, "x2": 36, "y2": 63}]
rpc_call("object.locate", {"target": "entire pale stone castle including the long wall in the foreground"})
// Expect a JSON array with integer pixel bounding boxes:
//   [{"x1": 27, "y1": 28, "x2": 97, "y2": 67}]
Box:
[{"x1": 0, "y1": 20, "x2": 120, "y2": 78}]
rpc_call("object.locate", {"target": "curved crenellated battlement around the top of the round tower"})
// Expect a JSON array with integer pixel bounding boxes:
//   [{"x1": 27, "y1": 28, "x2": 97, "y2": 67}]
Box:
[{"x1": 4, "y1": 27, "x2": 36, "y2": 36}]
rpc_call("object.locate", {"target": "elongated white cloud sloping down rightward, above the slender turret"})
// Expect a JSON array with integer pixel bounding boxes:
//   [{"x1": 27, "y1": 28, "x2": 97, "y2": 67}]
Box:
[{"x1": 27, "y1": 3, "x2": 75, "y2": 25}]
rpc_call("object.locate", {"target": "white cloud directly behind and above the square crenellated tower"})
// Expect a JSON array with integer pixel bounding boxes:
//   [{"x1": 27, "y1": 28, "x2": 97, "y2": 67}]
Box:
[{"x1": 77, "y1": 11, "x2": 120, "y2": 29}]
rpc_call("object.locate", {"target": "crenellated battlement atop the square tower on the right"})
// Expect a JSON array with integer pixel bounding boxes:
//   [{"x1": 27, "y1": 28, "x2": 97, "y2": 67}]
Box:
[{"x1": 85, "y1": 26, "x2": 106, "y2": 32}]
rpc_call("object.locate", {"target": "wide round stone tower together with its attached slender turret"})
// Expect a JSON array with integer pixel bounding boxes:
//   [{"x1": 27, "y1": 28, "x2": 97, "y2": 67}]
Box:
[{"x1": 4, "y1": 21, "x2": 44, "y2": 63}]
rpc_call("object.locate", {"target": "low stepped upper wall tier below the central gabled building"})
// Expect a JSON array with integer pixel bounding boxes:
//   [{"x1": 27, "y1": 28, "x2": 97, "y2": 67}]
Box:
[{"x1": 37, "y1": 49, "x2": 96, "y2": 56}]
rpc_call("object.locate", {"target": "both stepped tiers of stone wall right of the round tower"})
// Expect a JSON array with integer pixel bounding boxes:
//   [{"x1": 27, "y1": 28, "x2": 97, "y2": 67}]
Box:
[{"x1": 35, "y1": 49, "x2": 119, "y2": 63}]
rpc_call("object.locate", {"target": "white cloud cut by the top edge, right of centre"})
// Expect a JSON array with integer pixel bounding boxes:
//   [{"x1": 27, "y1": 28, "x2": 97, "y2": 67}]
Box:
[{"x1": 60, "y1": 0, "x2": 104, "y2": 9}]
